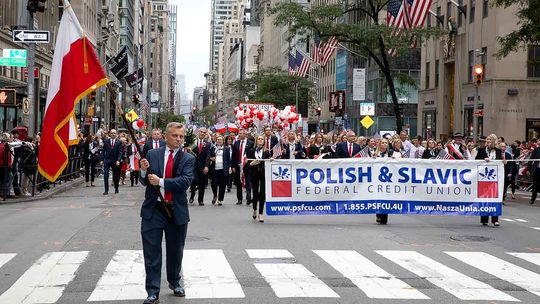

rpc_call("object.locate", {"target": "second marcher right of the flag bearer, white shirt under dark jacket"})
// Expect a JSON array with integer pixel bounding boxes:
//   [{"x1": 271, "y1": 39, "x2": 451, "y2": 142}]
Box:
[{"x1": 208, "y1": 135, "x2": 231, "y2": 206}]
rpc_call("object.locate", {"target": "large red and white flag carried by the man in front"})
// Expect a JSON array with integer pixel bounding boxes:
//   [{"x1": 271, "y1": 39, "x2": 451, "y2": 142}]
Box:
[{"x1": 38, "y1": 0, "x2": 109, "y2": 182}]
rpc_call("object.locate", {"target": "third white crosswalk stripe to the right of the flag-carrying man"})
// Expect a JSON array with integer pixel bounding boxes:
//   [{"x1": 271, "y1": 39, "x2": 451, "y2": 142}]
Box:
[{"x1": 314, "y1": 250, "x2": 429, "y2": 299}]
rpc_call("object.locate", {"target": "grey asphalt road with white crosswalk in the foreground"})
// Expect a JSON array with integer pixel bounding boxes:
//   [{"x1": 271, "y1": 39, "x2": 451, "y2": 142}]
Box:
[{"x1": 0, "y1": 181, "x2": 540, "y2": 304}]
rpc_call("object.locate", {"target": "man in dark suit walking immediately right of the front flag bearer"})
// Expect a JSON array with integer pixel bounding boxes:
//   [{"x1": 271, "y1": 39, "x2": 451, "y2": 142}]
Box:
[{"x1": 189, "y1": 128, "x2": 212, "y2": 206}]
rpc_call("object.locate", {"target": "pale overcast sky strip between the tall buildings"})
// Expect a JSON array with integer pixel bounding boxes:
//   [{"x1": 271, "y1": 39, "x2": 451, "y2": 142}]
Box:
[{"x1": 169, "y1": 0, "x2": 210, "y2": 96}]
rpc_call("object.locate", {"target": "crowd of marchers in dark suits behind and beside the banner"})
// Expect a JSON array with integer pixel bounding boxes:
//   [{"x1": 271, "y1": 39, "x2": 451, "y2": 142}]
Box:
[{"x1": 84, "y1": 126, "x2": 540, "y2": 226}]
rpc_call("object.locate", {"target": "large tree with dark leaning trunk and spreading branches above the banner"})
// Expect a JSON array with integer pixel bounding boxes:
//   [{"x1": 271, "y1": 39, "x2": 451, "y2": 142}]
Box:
[{"x1": 270, "y1": 0, "x2": 443, "y2": 131}]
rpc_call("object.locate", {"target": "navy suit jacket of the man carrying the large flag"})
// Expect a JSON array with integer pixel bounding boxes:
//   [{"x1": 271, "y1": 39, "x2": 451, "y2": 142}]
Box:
[{"x1": 140, "y1": 147, "x2": 195, "y2": 225}]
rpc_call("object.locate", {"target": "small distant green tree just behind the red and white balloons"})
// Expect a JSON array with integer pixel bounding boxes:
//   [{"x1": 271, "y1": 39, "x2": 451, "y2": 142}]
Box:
[{"x1": 227, "y1": 67, "x2": 313, "y2": 115}]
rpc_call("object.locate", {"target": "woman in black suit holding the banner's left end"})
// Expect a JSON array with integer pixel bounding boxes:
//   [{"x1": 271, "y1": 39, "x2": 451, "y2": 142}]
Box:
[{"x1": 247, "y1": 135, "x2": 270, "y2": 223}]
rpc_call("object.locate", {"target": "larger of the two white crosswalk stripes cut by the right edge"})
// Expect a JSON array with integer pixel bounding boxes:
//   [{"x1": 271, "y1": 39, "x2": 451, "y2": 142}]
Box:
[{"x1": 446, "y1": 252, "x2": 540, "y2": 296}]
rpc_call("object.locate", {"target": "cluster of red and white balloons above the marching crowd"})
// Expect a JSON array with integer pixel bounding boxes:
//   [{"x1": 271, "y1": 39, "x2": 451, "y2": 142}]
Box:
[{"x1": 233, "y1": 106, "x2": 300, "y2": 129}]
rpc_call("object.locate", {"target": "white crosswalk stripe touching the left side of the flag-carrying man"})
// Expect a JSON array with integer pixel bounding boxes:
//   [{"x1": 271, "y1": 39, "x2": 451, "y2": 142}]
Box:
[{"x1": 88, "y1": 250, "x2": 147, "y2": 302}]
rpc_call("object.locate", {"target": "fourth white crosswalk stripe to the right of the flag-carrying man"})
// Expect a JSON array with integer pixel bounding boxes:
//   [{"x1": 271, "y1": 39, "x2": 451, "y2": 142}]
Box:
[{"x1": 376, "y1": 250, "x2": 519, "y2": 301}]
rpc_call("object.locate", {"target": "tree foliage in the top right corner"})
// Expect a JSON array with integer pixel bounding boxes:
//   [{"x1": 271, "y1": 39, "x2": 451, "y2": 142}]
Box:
[{"x1": 493, "y1": 0, "x2": 540, "y2": 58}]
